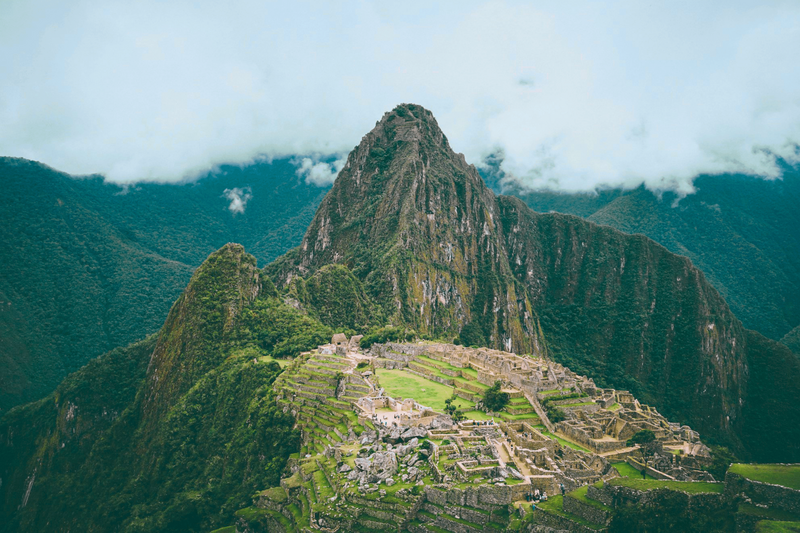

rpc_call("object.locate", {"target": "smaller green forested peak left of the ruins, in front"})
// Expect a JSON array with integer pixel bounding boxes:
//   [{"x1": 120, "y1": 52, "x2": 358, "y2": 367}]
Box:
[{"x1": 0, "y1": 244, "x2": 331, "y2": 532}]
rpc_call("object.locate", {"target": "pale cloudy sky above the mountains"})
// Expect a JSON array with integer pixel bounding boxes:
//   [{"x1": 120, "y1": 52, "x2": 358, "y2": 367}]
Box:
[{"x1": 0, "y1": 0, "x2": 800, "y2": 191}]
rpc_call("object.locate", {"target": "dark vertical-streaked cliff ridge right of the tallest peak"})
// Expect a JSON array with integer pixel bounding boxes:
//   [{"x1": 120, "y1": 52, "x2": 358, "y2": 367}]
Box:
[{"x1": 499, "y1": 197, "x2": 748, "y2": 445}]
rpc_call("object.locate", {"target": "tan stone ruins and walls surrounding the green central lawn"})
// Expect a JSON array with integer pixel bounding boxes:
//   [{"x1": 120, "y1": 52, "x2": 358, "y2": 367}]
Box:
[{"x1": 266, "y1": 334, "x2": 709, "y2": 523}]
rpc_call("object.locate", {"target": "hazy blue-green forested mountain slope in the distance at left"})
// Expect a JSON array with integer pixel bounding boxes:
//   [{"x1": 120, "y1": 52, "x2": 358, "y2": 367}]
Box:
[{"x1": 0, "y1": 158, "x2": 326, "y2": 413}]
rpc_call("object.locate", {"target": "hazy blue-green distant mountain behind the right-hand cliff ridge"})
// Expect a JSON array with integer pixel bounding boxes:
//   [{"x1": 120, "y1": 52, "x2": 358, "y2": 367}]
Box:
[{"x1": 494, "y1": 170, "x2": 800, "y2": 340}]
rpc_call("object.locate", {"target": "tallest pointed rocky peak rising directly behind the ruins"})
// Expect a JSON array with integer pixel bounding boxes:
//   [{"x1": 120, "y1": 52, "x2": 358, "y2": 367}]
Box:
[{"x1": 267, "y1": 105, "x2": 539, "y2": 352}]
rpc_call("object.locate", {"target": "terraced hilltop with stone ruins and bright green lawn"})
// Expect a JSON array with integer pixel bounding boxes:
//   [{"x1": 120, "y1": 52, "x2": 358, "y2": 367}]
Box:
[{"x1": 228, "y1": 335, "x2": 721, "y2": 533}]
